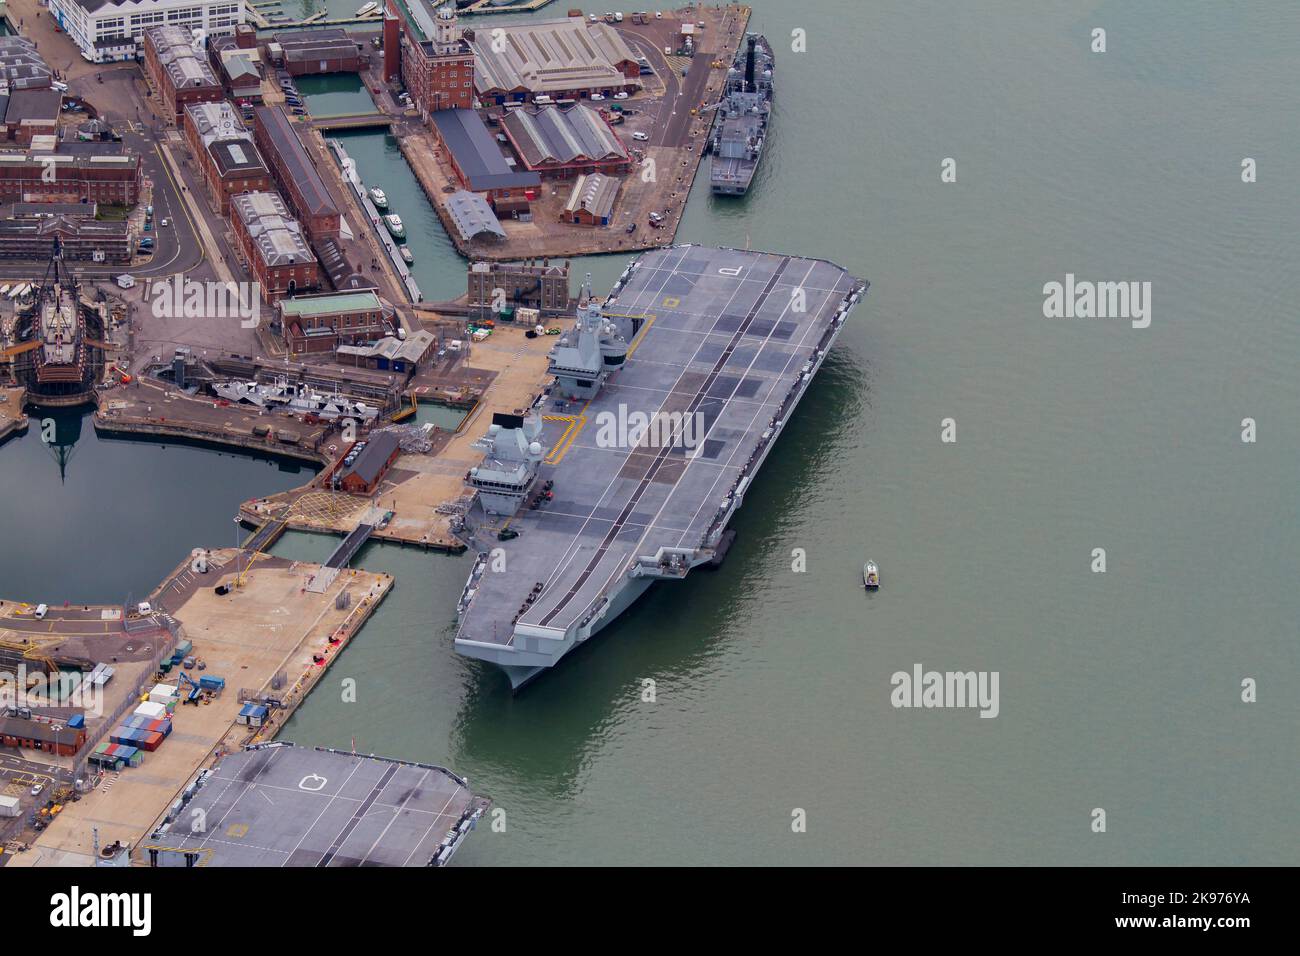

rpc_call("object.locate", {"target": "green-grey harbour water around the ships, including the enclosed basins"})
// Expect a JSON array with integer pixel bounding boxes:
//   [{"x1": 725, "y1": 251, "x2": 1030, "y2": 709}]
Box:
[{"x1": 0, "y1": 0, "x2": 1300, "y2": 865}]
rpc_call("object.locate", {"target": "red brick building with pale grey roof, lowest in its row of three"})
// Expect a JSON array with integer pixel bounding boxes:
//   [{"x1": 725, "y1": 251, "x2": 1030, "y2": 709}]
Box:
[{"x1": 230, "y1": 193, "x2": 321, "y2": 303}]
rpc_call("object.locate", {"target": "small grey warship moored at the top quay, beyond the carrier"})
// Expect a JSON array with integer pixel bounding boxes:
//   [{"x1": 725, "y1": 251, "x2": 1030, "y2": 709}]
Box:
[{"x1": 707, "y1": 34, "x2": 775, "y2": 196}]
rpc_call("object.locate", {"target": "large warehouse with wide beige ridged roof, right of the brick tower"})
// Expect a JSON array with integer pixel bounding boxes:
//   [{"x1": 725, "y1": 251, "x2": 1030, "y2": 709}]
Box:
[{"x1": 471, "y1": 17, "x2": 641, "y2": 104}]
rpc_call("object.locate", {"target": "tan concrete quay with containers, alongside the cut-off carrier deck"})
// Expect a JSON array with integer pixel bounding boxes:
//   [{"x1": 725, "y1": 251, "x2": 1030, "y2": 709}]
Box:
[{"x1": 8, "y1": 549, "x2": 393, "y2": 866}]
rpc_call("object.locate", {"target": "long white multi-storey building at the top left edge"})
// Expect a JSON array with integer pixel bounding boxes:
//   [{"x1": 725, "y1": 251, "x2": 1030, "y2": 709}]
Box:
[{"x1": 49, "y1": 0, "x2": 244, "y2": 62}]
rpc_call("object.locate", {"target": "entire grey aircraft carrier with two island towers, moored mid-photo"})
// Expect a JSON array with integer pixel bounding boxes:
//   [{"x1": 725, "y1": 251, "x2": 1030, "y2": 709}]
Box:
[{"x1": 455, "y1": 245, "x2": 867, "y2": 688}]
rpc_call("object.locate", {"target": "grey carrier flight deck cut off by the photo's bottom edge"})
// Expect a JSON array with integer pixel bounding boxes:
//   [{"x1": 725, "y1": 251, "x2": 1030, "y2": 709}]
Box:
[{"x1": 144, "y1": 741, "x2": 490, "y2": 866}]
